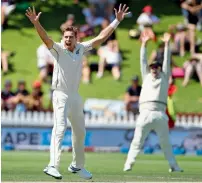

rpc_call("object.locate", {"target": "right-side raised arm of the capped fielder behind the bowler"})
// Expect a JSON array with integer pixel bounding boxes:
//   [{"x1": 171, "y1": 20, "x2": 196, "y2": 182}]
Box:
[{"x1": 161, "y1": 33, "x2": 171, "y2": 77}]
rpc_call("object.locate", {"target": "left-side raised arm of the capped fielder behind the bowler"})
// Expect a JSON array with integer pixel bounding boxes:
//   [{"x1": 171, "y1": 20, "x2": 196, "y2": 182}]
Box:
[{"x1": 140, "y1": 33, "x2": 149, "y2": 79}]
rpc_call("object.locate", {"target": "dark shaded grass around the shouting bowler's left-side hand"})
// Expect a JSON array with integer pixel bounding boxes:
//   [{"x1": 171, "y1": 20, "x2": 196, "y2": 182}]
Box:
[{"x1": 5, "y1": 0, "x2": 85, "y2": 31}]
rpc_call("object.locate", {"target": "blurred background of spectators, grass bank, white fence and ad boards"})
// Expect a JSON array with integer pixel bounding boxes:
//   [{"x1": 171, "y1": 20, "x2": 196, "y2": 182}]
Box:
[{"x1": 1, "y1": 0, "x2": 202, "y2": 154}]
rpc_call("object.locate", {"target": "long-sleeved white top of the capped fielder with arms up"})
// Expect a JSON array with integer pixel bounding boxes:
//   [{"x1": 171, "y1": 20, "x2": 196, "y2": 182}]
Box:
[{"x1": 139, "y1": 47, "x2": 170, "y2": 112}]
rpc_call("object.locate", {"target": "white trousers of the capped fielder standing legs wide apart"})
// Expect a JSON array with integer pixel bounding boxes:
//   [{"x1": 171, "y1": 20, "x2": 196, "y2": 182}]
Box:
[{"x1": 126, "y1": 110, "x2": 177, "y2": 166}]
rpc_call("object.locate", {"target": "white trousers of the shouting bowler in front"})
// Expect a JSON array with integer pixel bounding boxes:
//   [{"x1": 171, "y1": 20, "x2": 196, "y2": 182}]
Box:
[{"x1": 49, "y1": 90, "x2": 85, "y2": 168}]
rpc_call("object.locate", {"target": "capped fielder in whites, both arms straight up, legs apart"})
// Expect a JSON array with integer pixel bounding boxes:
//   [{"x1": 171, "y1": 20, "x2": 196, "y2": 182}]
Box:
[{"x1": 123, "y1": 33, "x2": 182, "y2": 172}]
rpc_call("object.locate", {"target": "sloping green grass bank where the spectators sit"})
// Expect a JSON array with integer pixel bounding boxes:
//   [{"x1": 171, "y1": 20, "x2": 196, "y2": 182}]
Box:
[{"x1": 2, "y1": 0, "x2": 202, "y2": 112}]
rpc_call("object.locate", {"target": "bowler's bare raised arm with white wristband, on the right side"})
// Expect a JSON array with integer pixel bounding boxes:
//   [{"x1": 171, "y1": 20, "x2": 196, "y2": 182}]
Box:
[{"x1": 90, "y1": 4, "x2": 130, "y2": 48}]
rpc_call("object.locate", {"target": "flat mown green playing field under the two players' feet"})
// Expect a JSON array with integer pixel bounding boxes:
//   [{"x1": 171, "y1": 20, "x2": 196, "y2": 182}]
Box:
[{"x1": 2, "y1": 151, "x2": 202, "y2": 182}]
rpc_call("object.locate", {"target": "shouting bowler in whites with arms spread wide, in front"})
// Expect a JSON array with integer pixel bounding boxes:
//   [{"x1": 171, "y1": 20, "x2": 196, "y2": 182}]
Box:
[{"x1": 26, "y1": 4, "x2": 130, "y2": 179}]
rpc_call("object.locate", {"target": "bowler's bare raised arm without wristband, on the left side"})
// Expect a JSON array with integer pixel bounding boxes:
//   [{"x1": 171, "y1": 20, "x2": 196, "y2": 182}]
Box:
[{"x1": 25, "y1": 7, "x2": 54, "y2": 49}]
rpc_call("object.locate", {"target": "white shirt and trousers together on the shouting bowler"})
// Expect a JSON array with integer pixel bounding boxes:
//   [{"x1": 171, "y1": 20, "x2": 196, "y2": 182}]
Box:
[{"x1": 49, "y1": 41, "x2": 92, "y2": 169}]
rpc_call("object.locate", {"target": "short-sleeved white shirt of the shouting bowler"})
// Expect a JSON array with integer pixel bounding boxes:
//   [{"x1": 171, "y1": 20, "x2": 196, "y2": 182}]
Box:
[{"x1": 50, "y1": 41, "x2": 92, "y2": 94}]
